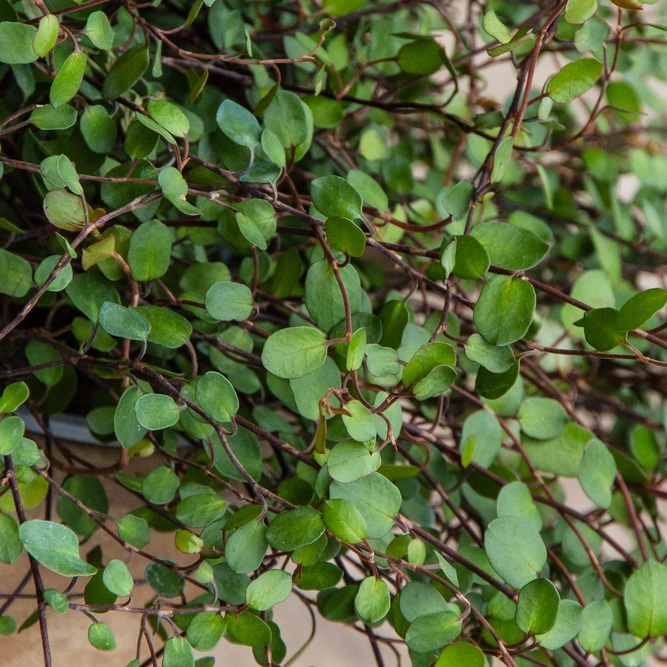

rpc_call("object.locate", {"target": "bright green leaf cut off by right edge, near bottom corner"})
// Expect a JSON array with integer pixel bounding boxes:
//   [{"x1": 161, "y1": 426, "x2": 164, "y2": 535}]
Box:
[{"x1": 623, "y1": 560, "x2": 667, "y2": 638}]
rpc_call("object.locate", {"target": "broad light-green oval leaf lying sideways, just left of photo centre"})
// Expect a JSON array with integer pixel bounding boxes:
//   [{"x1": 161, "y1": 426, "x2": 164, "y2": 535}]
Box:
[{"x1": 262, "y1": 327, "x2": 327, "y2": 379}]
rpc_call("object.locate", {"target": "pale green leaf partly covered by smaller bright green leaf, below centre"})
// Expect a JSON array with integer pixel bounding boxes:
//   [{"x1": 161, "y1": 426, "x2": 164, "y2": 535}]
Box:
[{"x1": 329, "y1": 472, "x2": 402, "y2": 538}]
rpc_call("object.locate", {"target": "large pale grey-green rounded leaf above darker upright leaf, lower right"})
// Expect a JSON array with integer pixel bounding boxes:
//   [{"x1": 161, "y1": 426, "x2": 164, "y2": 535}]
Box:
[{"x1": 484, "y1": 517, "x2": 547, "y2": 589}]
